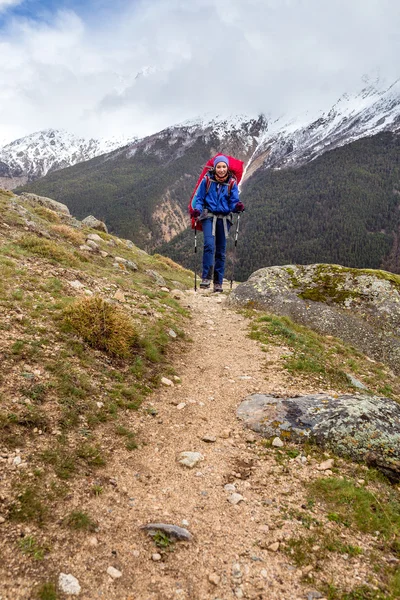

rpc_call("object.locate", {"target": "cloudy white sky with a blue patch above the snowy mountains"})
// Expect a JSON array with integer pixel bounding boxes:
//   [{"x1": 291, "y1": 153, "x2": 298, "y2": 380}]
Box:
[{"x1": 0, "y1": 0, "x2": 400, "y2": 143}]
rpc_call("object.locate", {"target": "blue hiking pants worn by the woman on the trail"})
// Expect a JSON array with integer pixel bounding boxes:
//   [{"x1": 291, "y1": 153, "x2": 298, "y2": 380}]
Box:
[{"x1": 201, "y1": 217, "x2": 231, "y2": 285}]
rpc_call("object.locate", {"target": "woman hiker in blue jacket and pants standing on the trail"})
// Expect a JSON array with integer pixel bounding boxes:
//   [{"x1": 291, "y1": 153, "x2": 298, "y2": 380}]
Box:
[{"x1": 192, "y1": 155, "x2": 244, "y2": 292}]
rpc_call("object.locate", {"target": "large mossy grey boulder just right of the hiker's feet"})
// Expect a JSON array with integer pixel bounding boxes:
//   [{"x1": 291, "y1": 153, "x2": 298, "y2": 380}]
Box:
[{"x1": 228, "y1": 264, "x2": 400, "y2": 374}]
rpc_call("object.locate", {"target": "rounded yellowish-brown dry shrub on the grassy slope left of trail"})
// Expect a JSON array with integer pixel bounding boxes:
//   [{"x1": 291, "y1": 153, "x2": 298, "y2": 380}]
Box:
[{"x1": 65, "y1": 296, "x2": 137, "y2": 358}]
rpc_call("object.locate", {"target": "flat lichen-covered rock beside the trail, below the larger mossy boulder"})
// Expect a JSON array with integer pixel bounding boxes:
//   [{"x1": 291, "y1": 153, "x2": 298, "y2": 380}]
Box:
[{"x1": 237, "y1": 394, "x2": 400, "y2": 481}]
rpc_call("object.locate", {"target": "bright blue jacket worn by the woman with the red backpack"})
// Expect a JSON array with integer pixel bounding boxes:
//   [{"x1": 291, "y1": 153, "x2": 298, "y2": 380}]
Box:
[{"x1": 192, "y1": 174, "x2": 239, "y2": 215}]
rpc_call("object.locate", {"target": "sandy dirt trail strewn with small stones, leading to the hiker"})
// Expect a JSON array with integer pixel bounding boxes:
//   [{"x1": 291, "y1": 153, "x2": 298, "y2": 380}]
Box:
[{"x1": 64, "y1": 294, "x2": 322, "y2": 600}]
